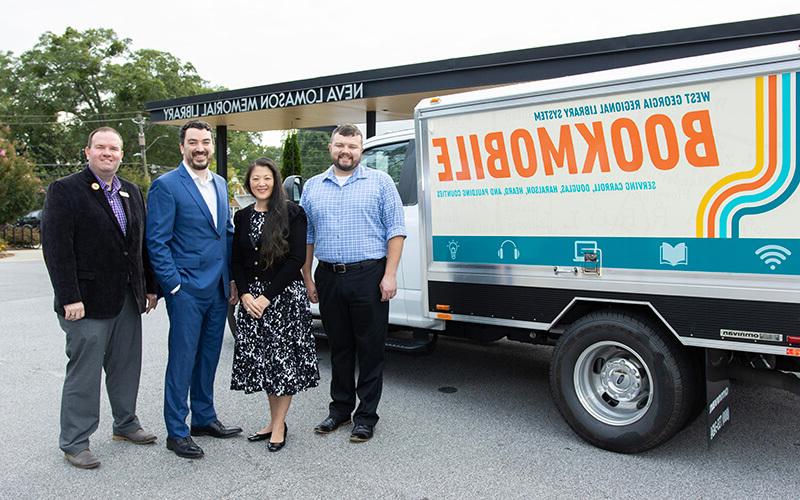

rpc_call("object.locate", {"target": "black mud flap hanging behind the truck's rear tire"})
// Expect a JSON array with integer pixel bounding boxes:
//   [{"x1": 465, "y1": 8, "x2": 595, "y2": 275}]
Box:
[{"x1": 704, "y1": 349, "x2": 731, "y2": 447}]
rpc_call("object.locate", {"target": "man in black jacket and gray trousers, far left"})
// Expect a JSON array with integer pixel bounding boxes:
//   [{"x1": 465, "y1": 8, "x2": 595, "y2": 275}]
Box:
[{"x1": 42, "y1": 127, "x2": 157, "y2": 469}]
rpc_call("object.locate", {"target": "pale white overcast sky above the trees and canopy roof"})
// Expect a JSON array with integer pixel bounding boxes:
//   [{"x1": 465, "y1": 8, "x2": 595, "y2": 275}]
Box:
[{"x1": 0, "y1": 0, "x2": 800, "y2": 142}]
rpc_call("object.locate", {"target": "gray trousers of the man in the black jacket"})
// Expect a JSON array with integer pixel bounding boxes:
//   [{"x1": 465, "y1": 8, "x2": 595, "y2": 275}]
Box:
[{"x1": 58, "y1": 291, "x2": 142, "y2": 455}]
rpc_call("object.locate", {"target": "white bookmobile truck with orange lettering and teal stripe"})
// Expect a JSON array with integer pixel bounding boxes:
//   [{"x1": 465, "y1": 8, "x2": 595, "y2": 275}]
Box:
[{"x1": 304, "y1": 43, "x2": 800, "y2": 453}]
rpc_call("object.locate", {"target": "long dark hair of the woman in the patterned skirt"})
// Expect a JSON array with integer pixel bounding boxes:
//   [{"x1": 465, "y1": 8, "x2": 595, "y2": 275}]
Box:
[{"x1": 244, "y1": 158, "x2": 289, "y2": 268}]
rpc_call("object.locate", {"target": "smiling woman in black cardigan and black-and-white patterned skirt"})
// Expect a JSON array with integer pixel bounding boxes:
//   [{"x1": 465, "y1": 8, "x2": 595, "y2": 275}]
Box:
[{"x1": 231, "y1": 158, "x2": 319, "y2": 451}]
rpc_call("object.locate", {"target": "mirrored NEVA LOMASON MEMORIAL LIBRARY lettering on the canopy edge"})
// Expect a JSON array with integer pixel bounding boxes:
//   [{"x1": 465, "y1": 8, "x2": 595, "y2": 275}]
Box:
[{"x1": 163, "y1": 83, "x2": 364, "y2": 121}]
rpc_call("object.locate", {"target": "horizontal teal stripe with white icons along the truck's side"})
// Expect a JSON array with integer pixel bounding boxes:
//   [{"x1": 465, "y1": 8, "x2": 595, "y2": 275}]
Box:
[{"x1": 433, "y1": 235, "x2": 800, "y2": 276}]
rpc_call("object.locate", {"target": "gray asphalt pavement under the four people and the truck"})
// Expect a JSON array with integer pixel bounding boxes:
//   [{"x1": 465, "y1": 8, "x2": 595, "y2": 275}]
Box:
[{"x1": 0, "y1": 250, "x2": 800, "y2": 499}]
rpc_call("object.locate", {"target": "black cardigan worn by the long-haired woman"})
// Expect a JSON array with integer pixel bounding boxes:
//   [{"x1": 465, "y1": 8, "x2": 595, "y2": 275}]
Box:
[{"x1": 231, "y1": 201, "x2": 308, "y2": 301}]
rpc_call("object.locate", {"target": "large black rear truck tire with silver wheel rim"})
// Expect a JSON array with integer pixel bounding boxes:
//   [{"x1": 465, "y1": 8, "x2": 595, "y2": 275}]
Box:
[{"x1": 550, "y1": 311, "x2": 696, "y2": 453}]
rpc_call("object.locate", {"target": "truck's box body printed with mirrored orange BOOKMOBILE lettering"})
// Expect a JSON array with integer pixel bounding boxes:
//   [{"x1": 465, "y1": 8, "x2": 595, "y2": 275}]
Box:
[{"x1": 416, "y1": 44, "x2": 800, "y2": 355}]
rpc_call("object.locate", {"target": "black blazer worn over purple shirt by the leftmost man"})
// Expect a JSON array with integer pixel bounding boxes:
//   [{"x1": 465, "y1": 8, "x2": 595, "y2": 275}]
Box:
[{"x1": 41, "y1": 167, "x2": 156, "y2": 319}]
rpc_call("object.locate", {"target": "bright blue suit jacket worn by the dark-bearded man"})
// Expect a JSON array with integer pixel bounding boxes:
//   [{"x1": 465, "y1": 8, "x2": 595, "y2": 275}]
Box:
[{"x1": 146, "y1": 163, "x2": 233, "y2": 298}]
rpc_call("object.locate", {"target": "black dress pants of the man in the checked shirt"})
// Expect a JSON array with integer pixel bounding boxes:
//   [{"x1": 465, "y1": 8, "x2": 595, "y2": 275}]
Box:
[{"x1": 314, "y1": 259, "x2": 389, "y2": 425}]
